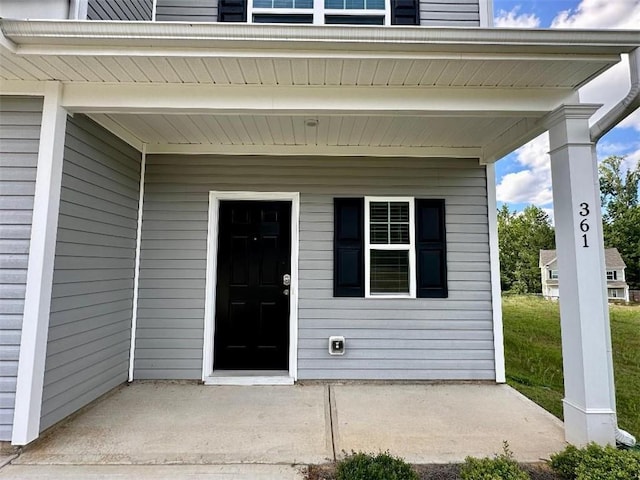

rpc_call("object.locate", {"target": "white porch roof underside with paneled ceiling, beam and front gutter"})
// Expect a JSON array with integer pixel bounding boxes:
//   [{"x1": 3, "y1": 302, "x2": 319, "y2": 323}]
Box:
[{"x1": 0, "y1": 20, "x2": 640, "y2": 161}]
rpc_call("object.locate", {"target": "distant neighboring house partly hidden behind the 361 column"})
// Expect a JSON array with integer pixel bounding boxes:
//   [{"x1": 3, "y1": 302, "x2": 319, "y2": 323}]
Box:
[{"x1": 539, "y1": 248, "x2": 629, "y2": 302}]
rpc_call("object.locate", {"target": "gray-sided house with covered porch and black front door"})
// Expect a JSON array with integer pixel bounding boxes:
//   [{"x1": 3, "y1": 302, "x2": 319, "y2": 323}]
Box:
[{"x1": 0, "y1": 0, "x2": 640, "y2": 445}]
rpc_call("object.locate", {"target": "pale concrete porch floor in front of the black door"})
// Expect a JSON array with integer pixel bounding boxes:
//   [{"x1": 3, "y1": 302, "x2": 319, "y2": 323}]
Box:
[{"x1": 0, "y1": 382, "x2": 564, "y2": 479}]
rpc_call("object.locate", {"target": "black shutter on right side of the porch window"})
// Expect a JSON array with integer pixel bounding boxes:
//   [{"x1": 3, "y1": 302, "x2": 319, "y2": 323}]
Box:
[{"x1": 416, "y1": 199, "x2": 448, "y2": 298}]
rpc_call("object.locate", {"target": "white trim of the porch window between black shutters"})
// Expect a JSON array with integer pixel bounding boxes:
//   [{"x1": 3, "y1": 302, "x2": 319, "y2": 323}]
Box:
[{"x1": 364, "y1": 196, "x2": 417, "y2": 298}]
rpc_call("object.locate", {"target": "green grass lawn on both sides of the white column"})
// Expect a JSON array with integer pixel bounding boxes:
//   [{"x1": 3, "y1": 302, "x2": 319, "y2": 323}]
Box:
[{"x1": 503, "y1": 296, "x2": 640, "y2": 439}]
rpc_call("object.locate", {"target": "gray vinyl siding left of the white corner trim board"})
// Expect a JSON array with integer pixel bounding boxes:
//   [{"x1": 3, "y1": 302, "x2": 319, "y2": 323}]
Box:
[{"x1": 0, "y1": 96, "x2": 42, "y2": 441}]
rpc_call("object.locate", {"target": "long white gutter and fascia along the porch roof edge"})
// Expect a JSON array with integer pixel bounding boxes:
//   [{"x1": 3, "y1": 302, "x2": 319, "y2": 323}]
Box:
[{"x1": 0, "y1": 19, "x2": 640, "y2": 55}]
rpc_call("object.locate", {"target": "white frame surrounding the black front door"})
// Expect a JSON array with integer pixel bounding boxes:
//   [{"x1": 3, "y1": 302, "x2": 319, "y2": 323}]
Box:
[{"x1": 202, "y1": 191, "x2": 300, "y2": 385}]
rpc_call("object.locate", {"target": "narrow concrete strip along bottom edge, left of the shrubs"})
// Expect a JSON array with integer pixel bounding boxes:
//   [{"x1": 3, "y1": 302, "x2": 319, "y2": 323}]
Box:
[{"x1": 0, "y1": 465, "x2": 304, "y2": 480}]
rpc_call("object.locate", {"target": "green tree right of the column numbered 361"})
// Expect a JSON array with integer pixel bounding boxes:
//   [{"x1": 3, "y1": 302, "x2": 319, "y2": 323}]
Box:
[{"x1": 598, "y1": 156, "x2": 640, "y2": 288}]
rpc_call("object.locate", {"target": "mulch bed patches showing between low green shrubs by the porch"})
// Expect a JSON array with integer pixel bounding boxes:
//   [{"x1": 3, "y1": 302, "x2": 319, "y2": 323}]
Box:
[{"x1": 306, "y1": 463, "x2": 560, "y2": 480}]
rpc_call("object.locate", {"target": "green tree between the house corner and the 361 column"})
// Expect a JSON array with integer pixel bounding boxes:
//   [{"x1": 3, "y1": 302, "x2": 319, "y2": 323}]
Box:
[{"x1": 498, "y1": 205, "x2": 555, "y2": 293}]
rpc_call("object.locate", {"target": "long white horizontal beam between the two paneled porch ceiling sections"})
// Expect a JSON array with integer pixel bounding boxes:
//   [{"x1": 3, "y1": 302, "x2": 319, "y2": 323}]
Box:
[{"x1": 62, "y1": 83, "x2": 571, "y2": 117}]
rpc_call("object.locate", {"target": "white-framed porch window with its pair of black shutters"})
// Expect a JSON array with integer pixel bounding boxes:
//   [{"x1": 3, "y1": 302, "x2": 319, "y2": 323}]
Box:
[{"x1": 334, "y1": 197, "x2": 448, "y2": 298}]
